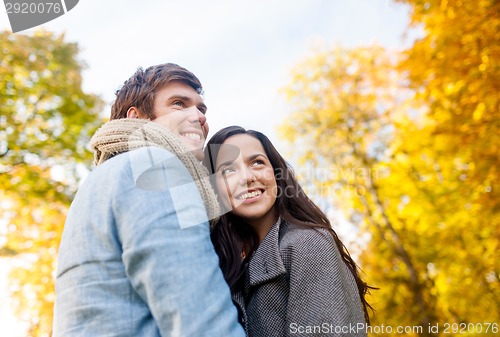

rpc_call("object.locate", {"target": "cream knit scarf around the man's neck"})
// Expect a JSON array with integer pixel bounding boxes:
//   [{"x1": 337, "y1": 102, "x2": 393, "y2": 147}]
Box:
[{"x1": 90, "y1": 118, "x2": 221, "y2": 225}]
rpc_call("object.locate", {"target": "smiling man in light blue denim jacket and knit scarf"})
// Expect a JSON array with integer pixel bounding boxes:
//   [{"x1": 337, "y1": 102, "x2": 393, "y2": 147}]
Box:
[{"x1": 54, "y1": 64, "x2": 244, "y2": 337}]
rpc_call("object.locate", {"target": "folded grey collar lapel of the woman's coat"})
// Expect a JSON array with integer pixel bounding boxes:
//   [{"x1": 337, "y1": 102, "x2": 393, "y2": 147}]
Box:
[{"x1": 248, "y1": 218, "x2": 286, "y2": 286}]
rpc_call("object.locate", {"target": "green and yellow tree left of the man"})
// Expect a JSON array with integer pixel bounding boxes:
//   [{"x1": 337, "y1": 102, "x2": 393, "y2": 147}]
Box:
[{"x1": 0, "y1": 32, "x2": 102, "y2": 336}]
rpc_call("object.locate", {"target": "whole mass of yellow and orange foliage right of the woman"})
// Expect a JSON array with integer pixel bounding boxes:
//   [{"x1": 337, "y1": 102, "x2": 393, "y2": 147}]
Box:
[{"x1": 282, "y1": 1, "x2": 500, "y2": 336}]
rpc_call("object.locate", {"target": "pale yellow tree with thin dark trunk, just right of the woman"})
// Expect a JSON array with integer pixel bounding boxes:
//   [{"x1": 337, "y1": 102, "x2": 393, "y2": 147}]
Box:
[{"x1": 282, "y1": 47, "x2": 442, "y2": 334}]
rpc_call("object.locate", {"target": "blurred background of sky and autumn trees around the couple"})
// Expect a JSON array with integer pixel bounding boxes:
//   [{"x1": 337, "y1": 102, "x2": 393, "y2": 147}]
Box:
[{"x1": 0, "y1": 0, "x2": 500, "y2": 337}]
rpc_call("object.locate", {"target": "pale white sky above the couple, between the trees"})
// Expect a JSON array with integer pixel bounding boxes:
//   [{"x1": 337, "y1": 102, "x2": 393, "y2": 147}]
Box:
[{"x1": 0, "y1": 0, "x2": 416, "y2": 337}]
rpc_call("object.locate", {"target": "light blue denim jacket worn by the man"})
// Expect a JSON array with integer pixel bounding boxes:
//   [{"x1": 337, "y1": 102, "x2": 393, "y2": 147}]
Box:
[{"x1": 53, "y1": 148, "x2": 244, "y2": 337}]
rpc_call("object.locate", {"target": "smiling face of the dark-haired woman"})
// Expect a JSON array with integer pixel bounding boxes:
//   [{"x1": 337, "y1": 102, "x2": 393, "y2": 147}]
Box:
[{"x1": 215, "y1": 134, "x2": 277, "y2": 224}]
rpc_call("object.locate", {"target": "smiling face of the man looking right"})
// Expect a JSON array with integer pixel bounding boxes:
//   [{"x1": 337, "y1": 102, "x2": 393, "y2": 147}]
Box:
[{"x1": 153, "y1": 81, "x2": 208, "y2": 161}]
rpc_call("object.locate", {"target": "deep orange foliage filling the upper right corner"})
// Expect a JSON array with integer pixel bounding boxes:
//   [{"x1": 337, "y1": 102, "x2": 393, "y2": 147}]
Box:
[{"x1": 400, "y1": 0, "x2": 500, "y2": 220}]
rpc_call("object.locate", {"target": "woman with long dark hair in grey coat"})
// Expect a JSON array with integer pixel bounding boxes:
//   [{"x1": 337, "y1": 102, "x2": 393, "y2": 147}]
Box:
[{"x1": 204, "y1": 126, "x2": 370, "y2": 337}]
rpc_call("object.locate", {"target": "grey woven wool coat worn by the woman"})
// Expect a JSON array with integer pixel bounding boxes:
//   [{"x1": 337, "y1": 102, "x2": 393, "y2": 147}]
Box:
[{"x1": 233, "y1": 220, "x2": 366, "y2": 337}]
